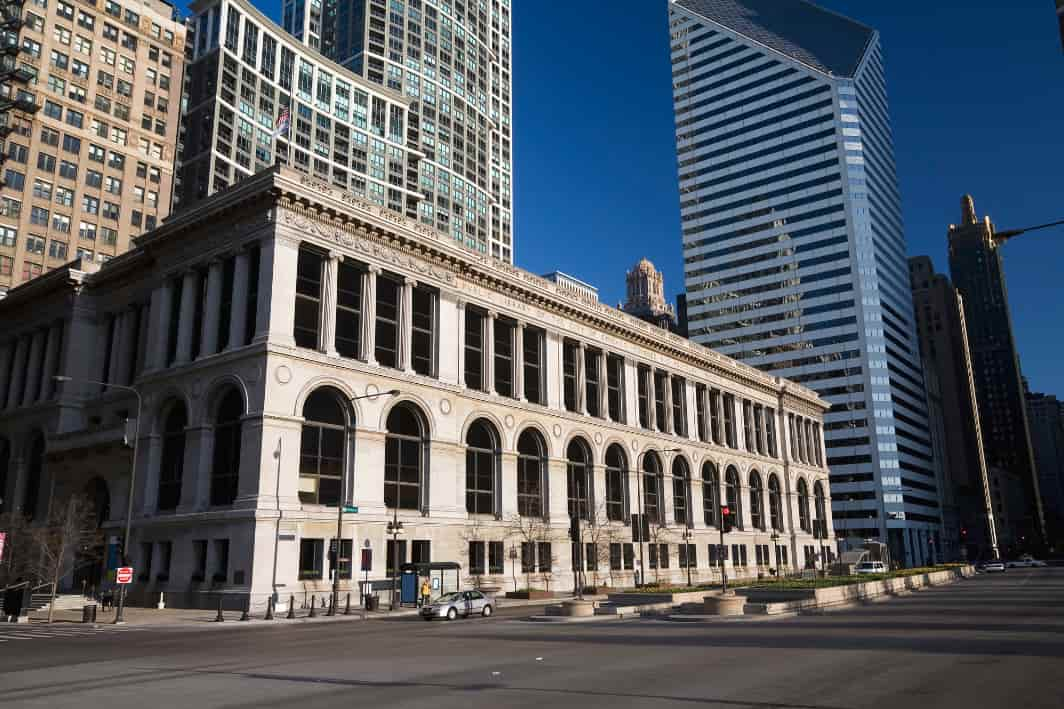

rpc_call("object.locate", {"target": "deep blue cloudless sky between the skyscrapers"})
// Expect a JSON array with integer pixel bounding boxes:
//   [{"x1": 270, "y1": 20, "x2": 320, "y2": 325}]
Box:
[{"x1": 243, "y1": 0, "x2": 1064, "y2": 395}]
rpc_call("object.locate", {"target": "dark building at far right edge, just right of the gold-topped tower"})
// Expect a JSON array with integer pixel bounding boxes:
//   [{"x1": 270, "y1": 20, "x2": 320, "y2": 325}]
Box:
[{"x1": 1025, "y1": 386, "x2": 1064, "y2": 544}]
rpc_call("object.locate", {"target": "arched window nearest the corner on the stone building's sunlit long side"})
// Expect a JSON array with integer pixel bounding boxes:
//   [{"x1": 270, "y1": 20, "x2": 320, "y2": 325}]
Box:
[{"x1": 299, "y1": 388, "x2": 348, "y2": 506}]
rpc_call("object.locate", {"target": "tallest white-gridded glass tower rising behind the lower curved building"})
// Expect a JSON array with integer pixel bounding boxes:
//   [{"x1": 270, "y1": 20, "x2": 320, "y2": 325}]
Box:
[{"x1": 282, "y1": 0, "x2": 514, "y2": 263}]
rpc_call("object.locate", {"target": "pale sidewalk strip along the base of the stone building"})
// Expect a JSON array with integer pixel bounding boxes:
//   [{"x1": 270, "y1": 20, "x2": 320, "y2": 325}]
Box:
[{"x1": 29, "y1": 596, "x2": 571, "y2": 628}]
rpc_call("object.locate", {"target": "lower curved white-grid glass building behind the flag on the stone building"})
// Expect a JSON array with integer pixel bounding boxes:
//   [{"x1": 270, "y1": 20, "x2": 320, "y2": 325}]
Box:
[{"x1": 181, "y1": 0, "x2": 420, "y2": 217}]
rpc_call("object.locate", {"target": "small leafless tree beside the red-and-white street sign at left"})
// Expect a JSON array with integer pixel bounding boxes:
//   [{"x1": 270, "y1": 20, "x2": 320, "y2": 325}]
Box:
[{"x1": 30, "y1": 495, "x2": 100, "y2": 623}]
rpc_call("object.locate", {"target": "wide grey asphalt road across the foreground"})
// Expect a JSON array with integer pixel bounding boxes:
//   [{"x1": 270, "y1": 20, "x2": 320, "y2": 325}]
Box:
[{"x1": 0, "y1": 568, "x2": 1064, "y2": 709}]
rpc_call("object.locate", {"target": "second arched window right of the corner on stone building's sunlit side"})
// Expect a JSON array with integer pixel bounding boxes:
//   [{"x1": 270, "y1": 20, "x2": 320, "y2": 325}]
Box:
[{"x1": 384, "y1": 401, "x2": 429, "y2": 510}]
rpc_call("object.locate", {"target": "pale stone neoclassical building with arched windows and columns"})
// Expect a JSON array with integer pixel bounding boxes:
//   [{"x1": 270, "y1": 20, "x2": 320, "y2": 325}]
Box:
[{"x1": 0, "y1": 168, "x2": 833, "y2": 608}]
